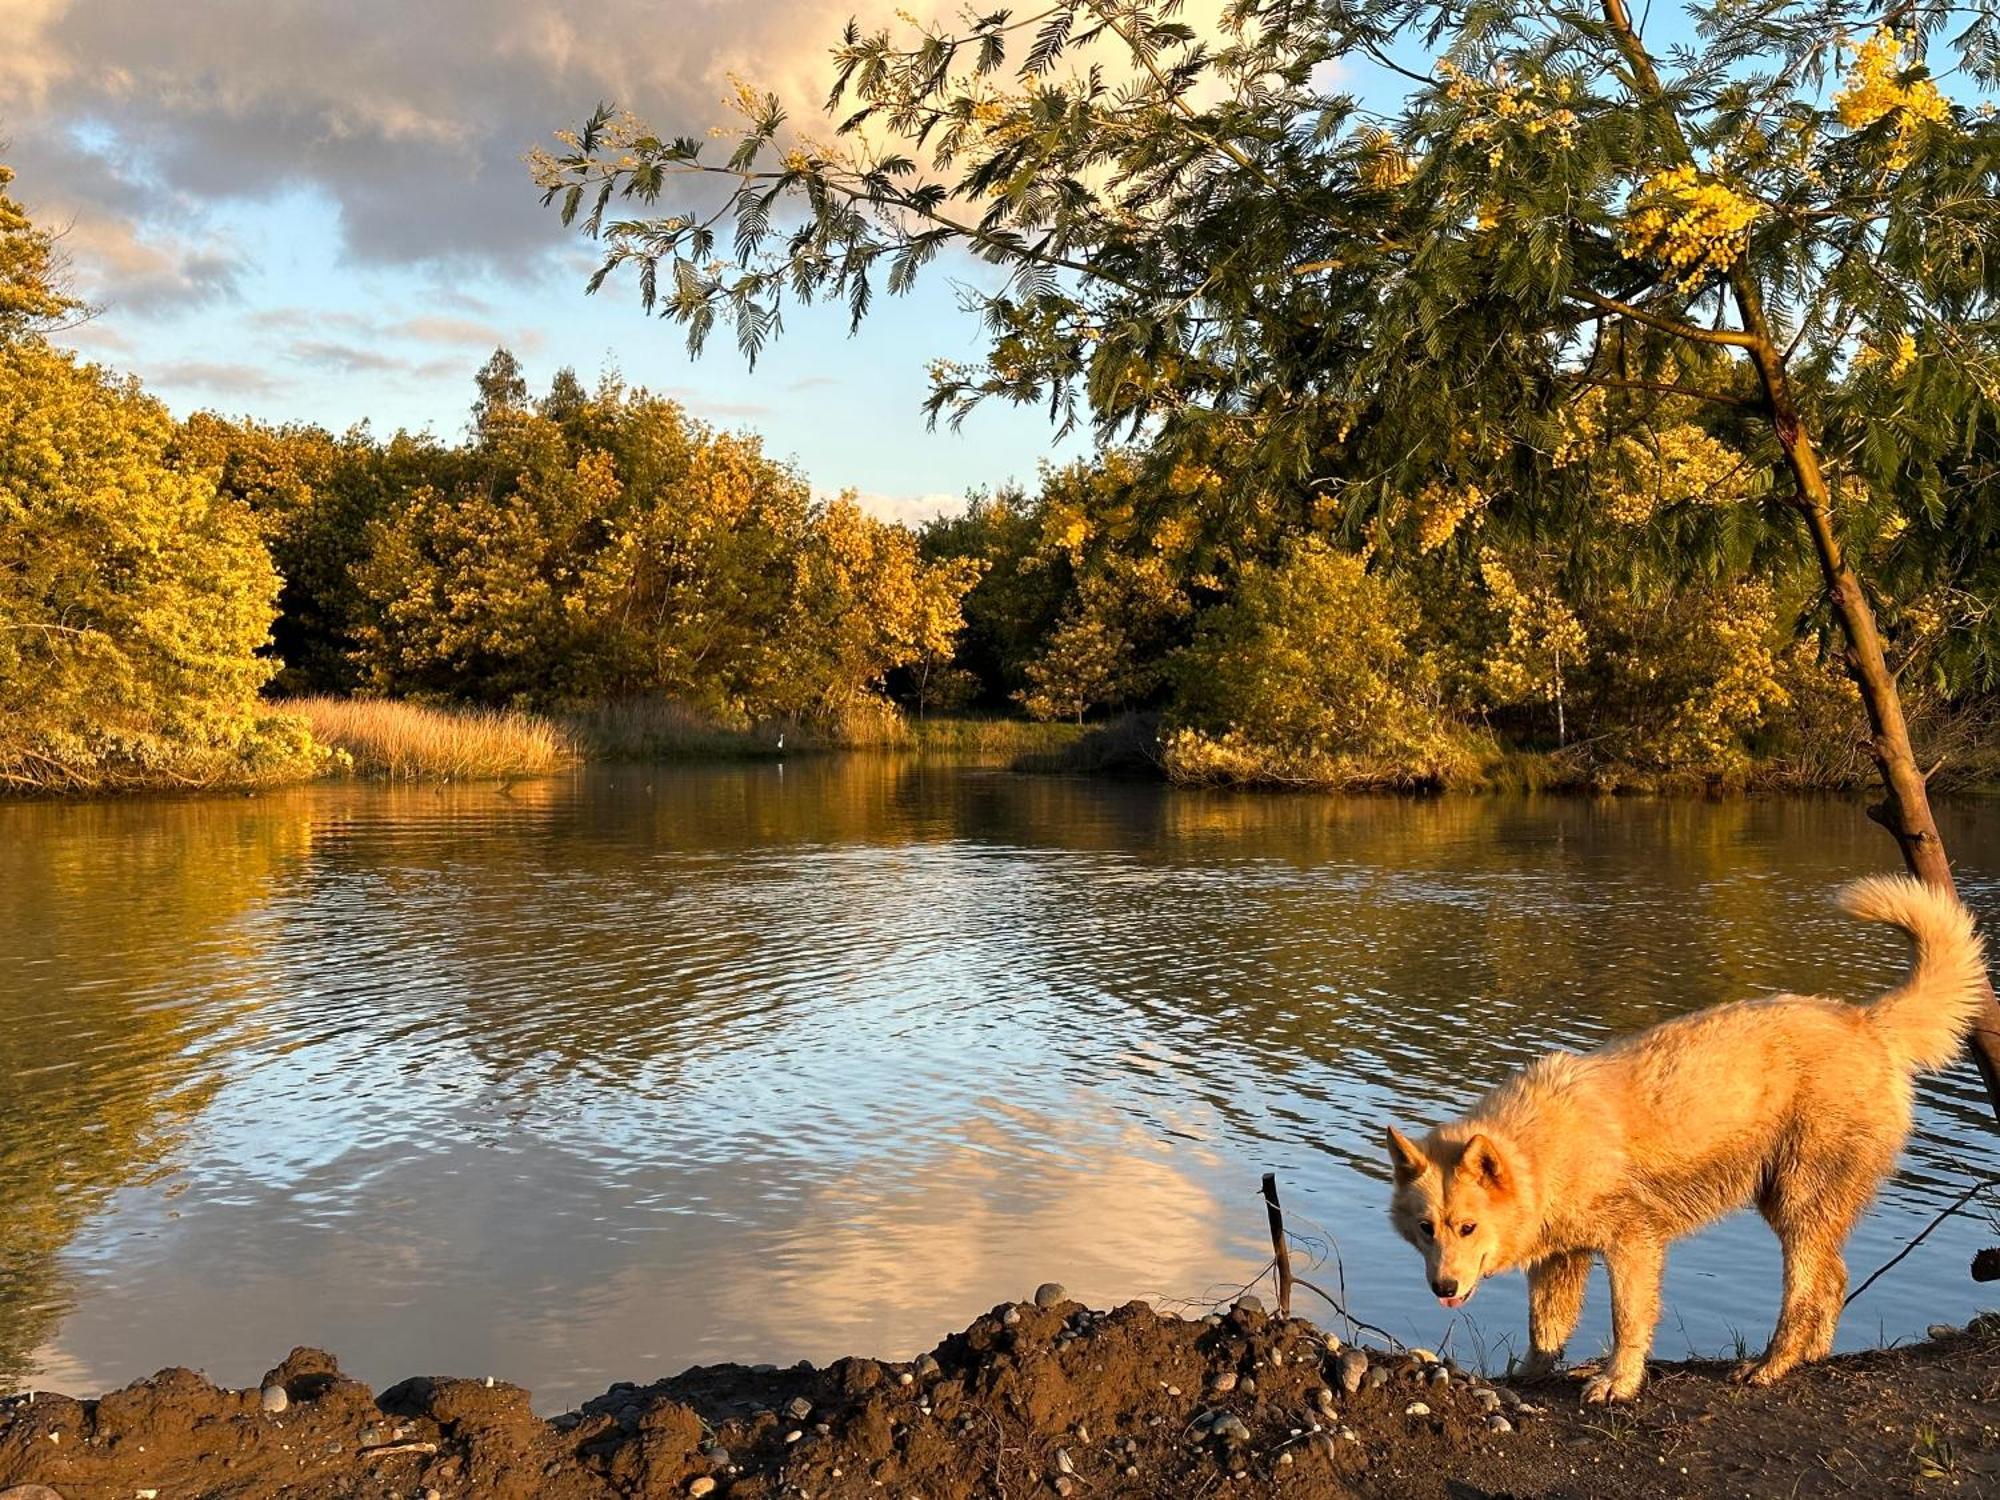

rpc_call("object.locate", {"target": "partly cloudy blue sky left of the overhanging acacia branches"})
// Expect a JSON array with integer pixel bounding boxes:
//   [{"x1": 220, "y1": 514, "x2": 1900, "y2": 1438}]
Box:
[{"x1": 0, "y1": 0, "x2": 1084, "y2": 520}]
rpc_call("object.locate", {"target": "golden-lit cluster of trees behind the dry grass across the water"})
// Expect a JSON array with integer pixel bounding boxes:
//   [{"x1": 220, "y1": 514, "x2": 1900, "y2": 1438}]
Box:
[{"x1": 176, "y1": 350, "x2": 978, "y2": 722}]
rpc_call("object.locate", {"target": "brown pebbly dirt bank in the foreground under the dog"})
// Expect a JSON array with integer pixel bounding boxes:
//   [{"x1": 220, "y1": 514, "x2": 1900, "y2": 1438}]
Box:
[{"x1": 0, "y1": 1288, "x2": 2000, "y2": 1500}]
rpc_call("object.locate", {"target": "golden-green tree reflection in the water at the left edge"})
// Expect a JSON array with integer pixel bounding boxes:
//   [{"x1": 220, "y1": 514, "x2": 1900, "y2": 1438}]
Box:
[{"x1": 0, "y1": 796, "x2": 310, "y2": 1384}]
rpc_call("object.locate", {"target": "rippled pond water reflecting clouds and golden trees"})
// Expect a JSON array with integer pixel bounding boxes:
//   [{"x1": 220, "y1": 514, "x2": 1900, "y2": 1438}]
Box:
[{"x1": 0, "y1": 758, "x2": 2000, "y2": 1410}]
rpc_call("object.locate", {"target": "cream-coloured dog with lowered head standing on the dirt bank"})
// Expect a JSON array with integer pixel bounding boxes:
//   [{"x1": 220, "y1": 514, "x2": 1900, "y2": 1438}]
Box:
[{"x1": 1388, "y1": 876, "x2": 1986, "y2": 1404}]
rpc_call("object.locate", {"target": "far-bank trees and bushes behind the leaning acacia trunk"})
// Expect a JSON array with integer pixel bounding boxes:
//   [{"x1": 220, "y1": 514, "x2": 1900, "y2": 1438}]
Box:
[{"x1": 922, "y1": 406, "x2": 2000, "y2": 788}]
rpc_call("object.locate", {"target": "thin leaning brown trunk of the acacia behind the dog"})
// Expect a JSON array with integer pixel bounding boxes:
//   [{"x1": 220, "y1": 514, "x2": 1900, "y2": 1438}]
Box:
[{"x1": 1602, "y1": 0, "x2": 2000, "y2": 1116}]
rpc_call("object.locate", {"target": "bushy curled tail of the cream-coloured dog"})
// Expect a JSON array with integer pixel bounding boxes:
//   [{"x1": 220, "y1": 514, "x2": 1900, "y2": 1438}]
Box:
[{"x1": 1840, "y1": 876, "x2": 1986, "y2": 1072}]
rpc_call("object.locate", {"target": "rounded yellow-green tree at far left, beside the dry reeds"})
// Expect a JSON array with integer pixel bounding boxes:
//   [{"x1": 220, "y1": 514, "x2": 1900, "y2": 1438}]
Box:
[{"x1": 0, "y1": 338, "x2": 318, "y2": 790}]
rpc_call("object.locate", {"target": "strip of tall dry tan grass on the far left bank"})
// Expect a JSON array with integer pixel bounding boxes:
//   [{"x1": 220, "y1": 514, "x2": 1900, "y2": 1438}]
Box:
[{"x1": 284, "y1": 698, "x2": 580, "y2": 782}]
